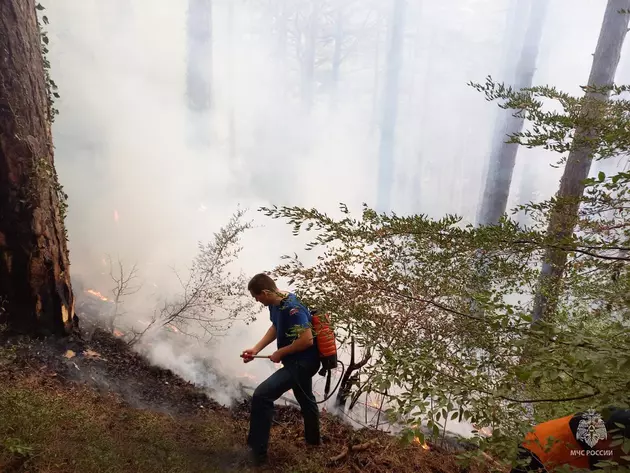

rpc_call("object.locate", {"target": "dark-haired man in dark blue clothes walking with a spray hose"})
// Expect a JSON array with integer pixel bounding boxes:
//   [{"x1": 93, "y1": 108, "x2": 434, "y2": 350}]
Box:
[{"x1": 241, "y1": 273, "x2": 320, "y2": 465}]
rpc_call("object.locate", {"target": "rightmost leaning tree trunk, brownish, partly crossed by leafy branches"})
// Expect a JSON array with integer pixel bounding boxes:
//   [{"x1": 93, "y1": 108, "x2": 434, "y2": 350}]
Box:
[{"x1": 532, "y1": 0, "x2": 630, "y2": 321}]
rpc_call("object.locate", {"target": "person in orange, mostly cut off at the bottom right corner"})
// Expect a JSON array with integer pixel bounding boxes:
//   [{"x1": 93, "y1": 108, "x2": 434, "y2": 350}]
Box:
[{"x1": 511, "y1": 407, "x2": 630, "y2": 473}]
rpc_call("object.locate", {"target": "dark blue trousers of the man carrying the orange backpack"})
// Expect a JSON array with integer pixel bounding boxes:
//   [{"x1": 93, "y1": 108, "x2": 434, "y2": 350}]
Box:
[{"x1": 247, "y1": 360, "x2": 320, "y2": 457}]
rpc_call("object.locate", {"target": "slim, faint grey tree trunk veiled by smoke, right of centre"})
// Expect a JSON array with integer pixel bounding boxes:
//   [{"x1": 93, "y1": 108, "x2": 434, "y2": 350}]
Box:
[{"x1": 376, "y1": 0, "x2": 406, "y2": 212}]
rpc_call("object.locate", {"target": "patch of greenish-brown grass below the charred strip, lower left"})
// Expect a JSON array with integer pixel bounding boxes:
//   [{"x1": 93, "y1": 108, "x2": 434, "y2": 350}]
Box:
[{"x1": 0, "y1": 383, "x2": 244, "y2": 473}]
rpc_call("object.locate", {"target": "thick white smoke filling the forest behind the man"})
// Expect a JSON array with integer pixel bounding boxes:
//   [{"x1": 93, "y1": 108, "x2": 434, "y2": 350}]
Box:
[{"x1": 44, "y1": 0, "x2": 624, "y2": 436}]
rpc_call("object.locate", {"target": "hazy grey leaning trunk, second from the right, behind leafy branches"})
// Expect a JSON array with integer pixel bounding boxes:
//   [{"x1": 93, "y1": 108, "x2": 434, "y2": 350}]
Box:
[{"x1": 477, "y1": 0, "x2": 549, "y2": 225}]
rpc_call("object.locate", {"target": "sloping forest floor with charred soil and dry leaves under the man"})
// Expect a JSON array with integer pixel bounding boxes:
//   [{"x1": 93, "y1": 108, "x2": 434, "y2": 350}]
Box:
[{"x1": 0, "y1": 320, "x2": 498, "y2": 473}]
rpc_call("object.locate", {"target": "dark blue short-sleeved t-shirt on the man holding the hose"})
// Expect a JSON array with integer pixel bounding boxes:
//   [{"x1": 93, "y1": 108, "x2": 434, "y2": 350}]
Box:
[{"x1": 269, "y1": 293, "x2": 319, "y2": 363}]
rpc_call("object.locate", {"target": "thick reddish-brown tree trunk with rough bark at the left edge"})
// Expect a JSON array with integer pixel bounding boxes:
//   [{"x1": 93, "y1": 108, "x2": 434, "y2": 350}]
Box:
[{"x1": 0, "y1": 0, "x2": 74, "y2": 335}]
